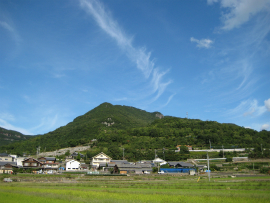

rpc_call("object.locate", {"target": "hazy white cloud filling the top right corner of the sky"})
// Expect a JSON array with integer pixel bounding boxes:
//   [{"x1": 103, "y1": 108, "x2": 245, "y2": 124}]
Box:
[{"x1": 210, "y1": 0, "x2": 270, "y2": 30}]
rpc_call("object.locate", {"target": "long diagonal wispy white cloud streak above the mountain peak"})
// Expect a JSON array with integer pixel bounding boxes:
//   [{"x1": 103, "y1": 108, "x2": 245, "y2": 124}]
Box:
[{"x1": 80, "y1": 0, "x2": 172, "y2": 102}]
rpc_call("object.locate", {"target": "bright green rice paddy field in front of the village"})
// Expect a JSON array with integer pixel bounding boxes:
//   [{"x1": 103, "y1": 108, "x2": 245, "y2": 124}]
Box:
[{"x1": 0, "y1": 174, "x2": 270, "y2": 203}]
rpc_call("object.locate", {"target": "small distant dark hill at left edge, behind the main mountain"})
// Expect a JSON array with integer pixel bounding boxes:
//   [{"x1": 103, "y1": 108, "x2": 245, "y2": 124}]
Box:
[{"x1": 0, "y1": 127, "x2": 32, "y2": 146}]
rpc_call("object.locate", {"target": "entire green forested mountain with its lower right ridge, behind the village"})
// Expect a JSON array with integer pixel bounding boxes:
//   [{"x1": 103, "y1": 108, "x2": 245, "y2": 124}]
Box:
[{"x1": 1, "y1": 103, "x2": 270, "y2": 160}]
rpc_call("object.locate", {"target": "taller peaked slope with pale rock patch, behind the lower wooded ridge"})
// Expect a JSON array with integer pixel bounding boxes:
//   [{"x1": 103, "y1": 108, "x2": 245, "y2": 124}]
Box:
[{"x1": 0, "y1": 103, "x2": 162, "y2": 154}]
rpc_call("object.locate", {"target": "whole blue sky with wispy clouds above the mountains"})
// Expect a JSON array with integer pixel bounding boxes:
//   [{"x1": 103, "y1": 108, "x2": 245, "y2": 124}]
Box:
[{"x1": 0, "y1": 0, "x2": 270, "y2": 135}]
